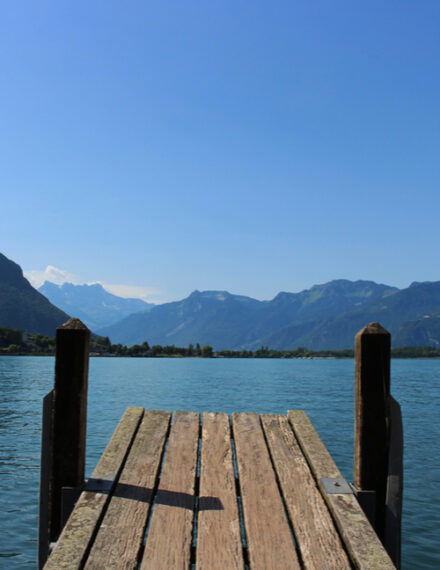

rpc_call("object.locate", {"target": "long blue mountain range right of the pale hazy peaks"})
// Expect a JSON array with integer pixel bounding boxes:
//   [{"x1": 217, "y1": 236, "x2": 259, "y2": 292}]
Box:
[{"x1": 97, "y1": 279, "x2": 440, "y2": 350}]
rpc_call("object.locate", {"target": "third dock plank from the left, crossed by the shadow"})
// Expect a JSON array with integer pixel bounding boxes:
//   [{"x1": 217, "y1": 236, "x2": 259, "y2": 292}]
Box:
[{"x1": 141, "y1": 412, "x2": 199, "y2": 570}]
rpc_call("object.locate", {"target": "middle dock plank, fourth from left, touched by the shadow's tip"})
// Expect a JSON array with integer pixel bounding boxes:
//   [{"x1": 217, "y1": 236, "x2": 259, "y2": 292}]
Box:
[{"x1": 196, "y1": 413, "x2": 244, "y2": 570}]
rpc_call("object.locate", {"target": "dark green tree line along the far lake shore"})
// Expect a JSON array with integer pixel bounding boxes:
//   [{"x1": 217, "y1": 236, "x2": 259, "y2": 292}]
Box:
[{"x1": 0, "y1": 327, "x2": 440, "y2": 358}]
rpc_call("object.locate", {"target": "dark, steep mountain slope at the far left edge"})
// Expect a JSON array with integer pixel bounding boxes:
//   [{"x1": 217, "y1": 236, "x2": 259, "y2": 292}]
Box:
[{"x1": 0, "y1": 253, "x2": 69, "y2": 337}]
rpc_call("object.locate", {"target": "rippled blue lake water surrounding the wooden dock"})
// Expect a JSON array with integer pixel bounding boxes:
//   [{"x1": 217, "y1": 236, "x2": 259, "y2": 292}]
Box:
[{"x1": 0, "y1": 357, "x2": 440, "y2": 569}]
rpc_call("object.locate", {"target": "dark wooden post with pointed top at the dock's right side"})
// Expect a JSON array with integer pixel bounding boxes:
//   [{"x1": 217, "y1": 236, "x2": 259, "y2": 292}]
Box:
[{"x1": 354, "y1": 323, "x2": 391, "y2": 542}]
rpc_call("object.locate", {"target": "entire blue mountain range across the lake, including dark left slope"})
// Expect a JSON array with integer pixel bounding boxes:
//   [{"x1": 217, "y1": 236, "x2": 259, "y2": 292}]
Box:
[{"x1": 0, "y1": 254, "x2": 440, "y2": 350}]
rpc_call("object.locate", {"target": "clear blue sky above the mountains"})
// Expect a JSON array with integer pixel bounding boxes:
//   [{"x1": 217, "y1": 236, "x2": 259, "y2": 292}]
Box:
[{"x1": 0, "y1": 0, "x2": 440, "y2": 301}]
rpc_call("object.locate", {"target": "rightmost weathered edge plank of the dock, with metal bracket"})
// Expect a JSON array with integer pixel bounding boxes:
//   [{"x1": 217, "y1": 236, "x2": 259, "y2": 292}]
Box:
[{"x1": 288, "y1": 410, "x2": 395, "y2": 570}]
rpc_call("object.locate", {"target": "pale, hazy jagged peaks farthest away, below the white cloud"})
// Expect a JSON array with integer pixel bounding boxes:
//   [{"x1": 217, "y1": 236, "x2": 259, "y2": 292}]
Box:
[{"x1": 38, "y1": 281, "x2": 153, "y2": 330}]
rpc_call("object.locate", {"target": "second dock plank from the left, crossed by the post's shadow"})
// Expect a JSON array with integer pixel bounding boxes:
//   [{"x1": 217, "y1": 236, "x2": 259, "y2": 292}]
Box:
[{"x1": 85, "y1": 410, "x2": 171, "y2": 570}]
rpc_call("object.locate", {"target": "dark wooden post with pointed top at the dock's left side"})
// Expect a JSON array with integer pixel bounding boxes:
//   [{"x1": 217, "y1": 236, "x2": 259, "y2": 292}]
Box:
[{"x1": 49, "y1": 319, "x2": 90, "y2": 542}]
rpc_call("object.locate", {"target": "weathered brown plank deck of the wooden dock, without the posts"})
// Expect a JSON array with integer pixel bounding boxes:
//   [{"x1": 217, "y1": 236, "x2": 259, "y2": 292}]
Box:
[{"x1": 40, "y1": 318, "x2": 400, "y2": 570}]
